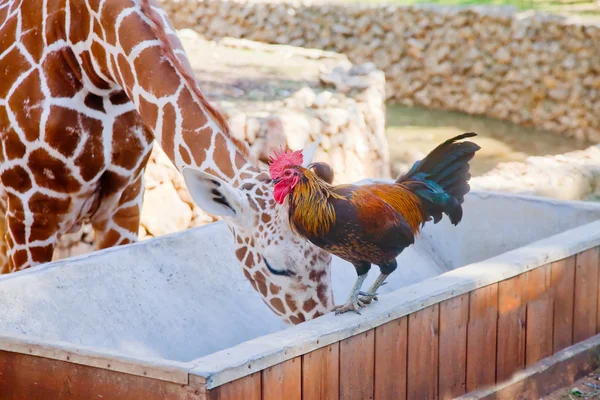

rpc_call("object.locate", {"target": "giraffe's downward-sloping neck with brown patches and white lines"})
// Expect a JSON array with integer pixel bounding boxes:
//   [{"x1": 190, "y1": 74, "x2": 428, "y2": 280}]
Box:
[{"x1": 81, "y1": 0, "x2": 259, "y2": 185}]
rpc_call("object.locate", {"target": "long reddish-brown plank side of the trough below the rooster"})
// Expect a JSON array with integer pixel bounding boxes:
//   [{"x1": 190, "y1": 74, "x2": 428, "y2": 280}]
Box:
[{"x1": 206, "y1": 247, "x2": 600, "y2": 400}]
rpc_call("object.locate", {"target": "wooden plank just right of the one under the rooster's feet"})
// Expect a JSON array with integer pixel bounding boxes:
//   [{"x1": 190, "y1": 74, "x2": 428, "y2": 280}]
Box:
[{"x1": 375, "y1": 317, "x2": 408, "y2": 400}]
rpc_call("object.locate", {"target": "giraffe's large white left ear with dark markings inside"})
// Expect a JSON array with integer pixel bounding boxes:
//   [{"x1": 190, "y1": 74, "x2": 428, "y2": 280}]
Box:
[{"x1": 182, "y1": 167, "x2": 241, "y2": 217}]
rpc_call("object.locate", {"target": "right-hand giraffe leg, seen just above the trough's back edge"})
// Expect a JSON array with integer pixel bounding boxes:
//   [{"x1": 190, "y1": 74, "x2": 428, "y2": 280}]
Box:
[{"x1": 92, "y1": 175, "x2": 144, "y2": 250}]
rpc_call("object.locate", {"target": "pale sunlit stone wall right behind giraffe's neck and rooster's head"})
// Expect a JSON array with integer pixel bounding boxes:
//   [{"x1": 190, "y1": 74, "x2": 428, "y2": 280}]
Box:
[{"x1": 55, "y1": 30, "x2": 390, "y2": 259}]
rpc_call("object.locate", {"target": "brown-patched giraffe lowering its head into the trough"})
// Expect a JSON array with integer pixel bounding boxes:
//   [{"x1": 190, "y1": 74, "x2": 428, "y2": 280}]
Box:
[{"x1": 0, "y1": 0, "x2": 333, "y2": 324}]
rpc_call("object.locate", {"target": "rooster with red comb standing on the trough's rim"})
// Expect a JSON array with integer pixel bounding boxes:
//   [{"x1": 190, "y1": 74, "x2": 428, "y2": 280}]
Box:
[{"x1": 269, "y1": 132, "x2": 480, "y2": 315}]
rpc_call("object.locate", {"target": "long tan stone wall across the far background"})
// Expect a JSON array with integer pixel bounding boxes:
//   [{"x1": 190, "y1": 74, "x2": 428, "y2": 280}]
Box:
[{"x1": 161, "y1": 0, "x2": 600, "y2": 141}]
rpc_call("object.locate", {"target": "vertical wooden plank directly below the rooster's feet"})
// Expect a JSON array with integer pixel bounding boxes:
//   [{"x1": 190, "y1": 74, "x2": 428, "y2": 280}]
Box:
[{"x1": 340, "y1": 329, "x2": 372, "y2": 400}]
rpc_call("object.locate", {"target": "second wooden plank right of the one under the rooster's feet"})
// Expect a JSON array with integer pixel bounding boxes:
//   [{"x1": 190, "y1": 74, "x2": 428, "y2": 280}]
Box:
[{"x1": 406, "y1": 304, "x2": 439, "y2": 399}]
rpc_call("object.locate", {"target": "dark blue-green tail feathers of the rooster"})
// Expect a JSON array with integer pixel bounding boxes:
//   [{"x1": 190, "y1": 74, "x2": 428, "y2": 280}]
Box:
[{"x1": 396, "y1": 132, "x2": 481, "y2": 225}]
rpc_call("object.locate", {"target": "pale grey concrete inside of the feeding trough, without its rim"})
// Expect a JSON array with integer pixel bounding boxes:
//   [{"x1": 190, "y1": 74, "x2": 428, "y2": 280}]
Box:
[{"x1": 0, "y1": 193, "x2": 600, "y2": 361}]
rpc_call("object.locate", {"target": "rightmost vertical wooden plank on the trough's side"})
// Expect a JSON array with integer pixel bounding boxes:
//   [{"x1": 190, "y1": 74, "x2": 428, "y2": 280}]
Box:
[{"x1": 573, "y1": 247, "x2": 599, "y2": 343}]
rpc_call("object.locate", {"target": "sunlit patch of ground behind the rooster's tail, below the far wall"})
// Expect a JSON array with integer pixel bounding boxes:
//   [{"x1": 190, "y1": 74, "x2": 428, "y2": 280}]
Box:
[{"x1": 386, "y1": 105, "x2": 592, "y2": 176}]
